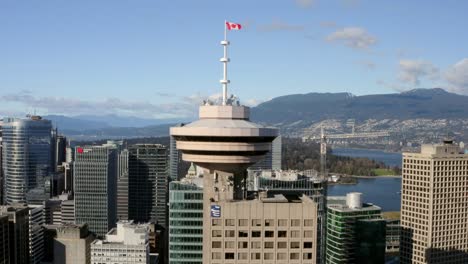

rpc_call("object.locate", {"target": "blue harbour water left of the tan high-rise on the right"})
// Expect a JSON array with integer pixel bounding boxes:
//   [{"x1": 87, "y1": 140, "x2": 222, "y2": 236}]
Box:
[{"x1": 328, "y1": 148, "x2": 401, "y2": 211}]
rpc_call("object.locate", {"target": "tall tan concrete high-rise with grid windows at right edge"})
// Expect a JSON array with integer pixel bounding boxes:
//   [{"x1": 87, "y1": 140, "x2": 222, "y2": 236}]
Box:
[{"x1": 400, "y1": 140, "x2": 468, "y2": 264}]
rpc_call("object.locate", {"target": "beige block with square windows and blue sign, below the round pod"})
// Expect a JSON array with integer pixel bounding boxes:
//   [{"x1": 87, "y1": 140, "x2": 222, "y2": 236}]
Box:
[{"x1": 208, "y1": 195, "x2": 317, "y2": 263}]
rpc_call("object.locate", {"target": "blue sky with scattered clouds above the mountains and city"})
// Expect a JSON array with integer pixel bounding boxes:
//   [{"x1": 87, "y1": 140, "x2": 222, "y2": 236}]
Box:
[{"x1": 0, "y1": 0, "x2": 468, "y2": 118}]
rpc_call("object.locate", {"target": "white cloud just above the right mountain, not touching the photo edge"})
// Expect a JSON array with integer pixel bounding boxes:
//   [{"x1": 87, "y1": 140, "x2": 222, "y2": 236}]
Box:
[{"x1": 398, "y1": 60, "x2": 439, "y2": 86}]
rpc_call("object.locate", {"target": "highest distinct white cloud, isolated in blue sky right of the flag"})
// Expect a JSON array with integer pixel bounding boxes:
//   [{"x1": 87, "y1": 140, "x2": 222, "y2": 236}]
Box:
[{"x1": 326, "y1": 27, "x2": 377, "y2": 50}]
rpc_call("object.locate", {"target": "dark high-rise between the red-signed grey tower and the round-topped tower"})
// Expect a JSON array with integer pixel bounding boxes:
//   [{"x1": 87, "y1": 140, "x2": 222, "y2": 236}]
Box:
[{"x1": 128, "y1": 144, "x2": 168, "y2": 227}]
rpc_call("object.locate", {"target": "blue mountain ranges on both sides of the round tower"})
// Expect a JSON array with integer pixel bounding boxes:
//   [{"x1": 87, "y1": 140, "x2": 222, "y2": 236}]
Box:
[{"x1": 35, "y1": 88, "x2": 468, "y2": 141}]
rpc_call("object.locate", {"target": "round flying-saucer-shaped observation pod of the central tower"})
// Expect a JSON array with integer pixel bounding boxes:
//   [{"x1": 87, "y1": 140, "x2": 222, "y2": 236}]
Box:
[{"x1": 170, "y1": 105, "x2": 278, "y2": 173}]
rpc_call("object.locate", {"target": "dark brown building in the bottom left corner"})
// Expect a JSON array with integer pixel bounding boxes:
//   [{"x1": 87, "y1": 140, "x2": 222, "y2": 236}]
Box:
[{"x1": 0, "y1": 204, "x2": 29, "y2": 264}]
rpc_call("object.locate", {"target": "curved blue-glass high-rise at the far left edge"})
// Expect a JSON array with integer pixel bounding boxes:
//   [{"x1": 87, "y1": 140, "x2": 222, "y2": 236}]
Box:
[{"x1": 2, "y1": 116, "x2": 52, "y2": 204}]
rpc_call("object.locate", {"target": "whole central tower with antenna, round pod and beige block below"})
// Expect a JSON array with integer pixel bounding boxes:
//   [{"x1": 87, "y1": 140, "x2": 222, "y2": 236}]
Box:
[{"x1": 170, "y1": 24, "x2": 317, "y2": 263}]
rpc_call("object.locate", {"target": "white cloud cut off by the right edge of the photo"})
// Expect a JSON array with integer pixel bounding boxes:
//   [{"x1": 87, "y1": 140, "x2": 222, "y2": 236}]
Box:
[{"x1": 444, "y1": 58, "x2": 468, "y2": 94}]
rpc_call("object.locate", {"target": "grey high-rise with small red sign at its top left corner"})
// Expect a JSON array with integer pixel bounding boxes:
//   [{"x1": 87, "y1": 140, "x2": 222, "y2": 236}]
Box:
[{"x1": 73, "y1": 144, "x2": 117, "y2": 237}]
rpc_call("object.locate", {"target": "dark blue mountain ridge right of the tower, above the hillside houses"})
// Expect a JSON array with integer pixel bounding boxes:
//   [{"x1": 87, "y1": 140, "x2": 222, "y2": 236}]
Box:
[{"x1": 252, "y1": 88, "x2": 468, "y2": 126}]
